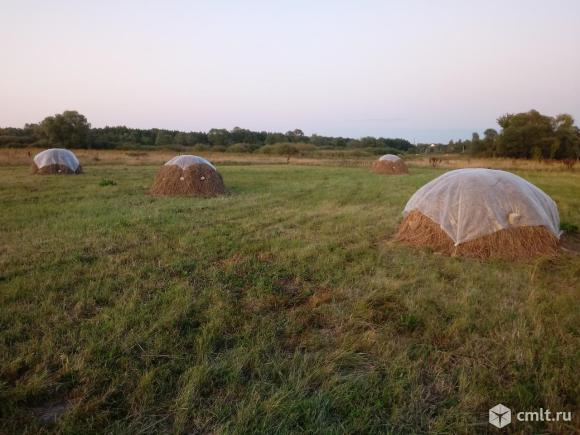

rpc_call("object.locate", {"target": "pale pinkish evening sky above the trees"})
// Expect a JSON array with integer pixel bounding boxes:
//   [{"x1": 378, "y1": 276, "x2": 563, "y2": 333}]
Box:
[{"x1": 0, "y1": 0, "x2": 580, "y2": 142}]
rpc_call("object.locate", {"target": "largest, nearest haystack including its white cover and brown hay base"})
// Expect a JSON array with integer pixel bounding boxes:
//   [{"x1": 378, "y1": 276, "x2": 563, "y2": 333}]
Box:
[{"x1": 396, "y1": 168, "x2": 561, "y2": 259}]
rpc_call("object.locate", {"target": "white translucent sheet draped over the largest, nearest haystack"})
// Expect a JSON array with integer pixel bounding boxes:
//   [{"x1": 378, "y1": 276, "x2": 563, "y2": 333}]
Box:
[{"x1": 403, "y1": 168, "x2": 561, "y2": 245}]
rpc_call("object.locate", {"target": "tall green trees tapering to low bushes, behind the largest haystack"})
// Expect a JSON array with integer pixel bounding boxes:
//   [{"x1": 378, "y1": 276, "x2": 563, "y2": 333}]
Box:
[{"x1": 417, "y1": 110, "x2": 580, "y2": 160}]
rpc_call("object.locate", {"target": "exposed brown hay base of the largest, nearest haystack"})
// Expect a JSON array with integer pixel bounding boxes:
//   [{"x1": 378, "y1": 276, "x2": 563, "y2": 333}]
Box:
[{"x1": 395, "y1": 211, "x2": 558, "y2": 260}]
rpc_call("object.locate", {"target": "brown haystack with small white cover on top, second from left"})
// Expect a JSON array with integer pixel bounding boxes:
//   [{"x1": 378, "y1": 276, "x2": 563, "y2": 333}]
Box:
[{"x1": 151, "y1": 155, "x2": 226, "y2": 196}]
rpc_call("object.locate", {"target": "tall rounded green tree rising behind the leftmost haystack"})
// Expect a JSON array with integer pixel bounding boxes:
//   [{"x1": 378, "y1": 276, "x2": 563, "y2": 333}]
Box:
[{"x1": 38, "y1": 110, "x2": 91, "y2": 147}]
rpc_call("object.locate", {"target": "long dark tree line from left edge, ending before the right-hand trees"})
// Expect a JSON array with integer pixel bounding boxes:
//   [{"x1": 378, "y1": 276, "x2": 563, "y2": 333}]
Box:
[{"x1": 0, "y1": 111, "x2": 413, "y2": 154}]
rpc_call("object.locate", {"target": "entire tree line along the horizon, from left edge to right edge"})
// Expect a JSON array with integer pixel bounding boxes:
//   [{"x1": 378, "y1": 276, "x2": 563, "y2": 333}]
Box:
[{"x1": 0, "y1": 110, "x2": 580, "y2": 160}]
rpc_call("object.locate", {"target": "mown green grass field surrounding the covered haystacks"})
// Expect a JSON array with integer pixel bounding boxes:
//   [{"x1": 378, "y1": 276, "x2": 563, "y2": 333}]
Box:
[{"x1": 0, "y1": 165, "x2": 580, "y2": 434}]
